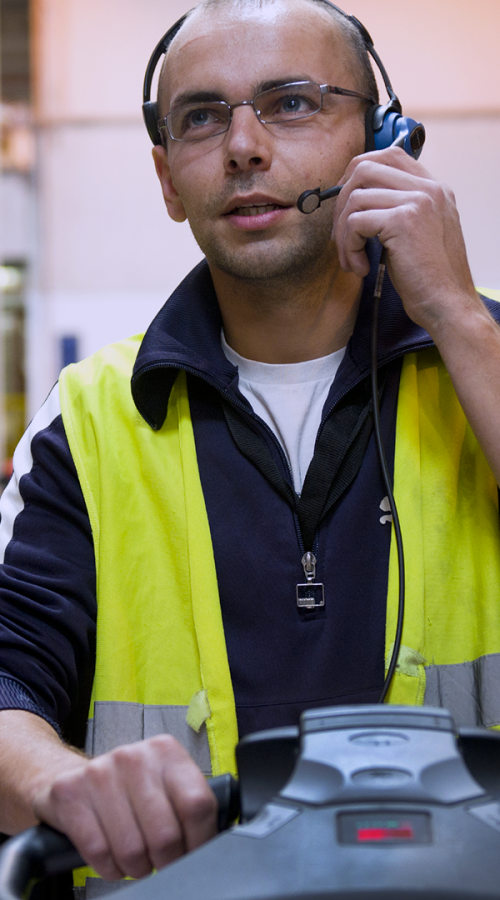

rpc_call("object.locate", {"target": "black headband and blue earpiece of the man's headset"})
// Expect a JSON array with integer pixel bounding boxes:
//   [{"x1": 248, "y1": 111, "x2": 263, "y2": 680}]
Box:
[{"x1": 142, "y1": 0, "x2": 425, "y2": 163}]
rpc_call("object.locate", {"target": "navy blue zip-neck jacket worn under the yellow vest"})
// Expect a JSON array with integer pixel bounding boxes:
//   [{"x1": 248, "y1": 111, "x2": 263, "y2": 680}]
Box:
[{"x1": 0, "y1": 245, "x2": 498, "y2": 744}]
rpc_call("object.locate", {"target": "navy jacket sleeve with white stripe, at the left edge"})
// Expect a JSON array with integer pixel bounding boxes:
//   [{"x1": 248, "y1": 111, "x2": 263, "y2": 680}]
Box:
[{"x1": 0, "y1": 386, "x2": 96, "y2": 746}]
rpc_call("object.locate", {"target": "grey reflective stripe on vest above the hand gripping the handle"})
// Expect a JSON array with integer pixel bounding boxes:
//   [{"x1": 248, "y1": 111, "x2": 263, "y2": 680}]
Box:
[{"x1": 85, "y1": 700, "x2": 212, "y2": 775}]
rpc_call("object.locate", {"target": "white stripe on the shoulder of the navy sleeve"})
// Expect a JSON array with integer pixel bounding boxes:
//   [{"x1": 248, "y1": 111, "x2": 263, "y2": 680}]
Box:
[{"x1": 0, "y1": 384, "x2": 61, "y2": 563}]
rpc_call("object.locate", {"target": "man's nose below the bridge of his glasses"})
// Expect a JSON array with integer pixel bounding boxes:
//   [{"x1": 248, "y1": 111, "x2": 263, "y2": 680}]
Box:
[{"x1": 224, "y1": 104, "x2": 272, "y2": 173}]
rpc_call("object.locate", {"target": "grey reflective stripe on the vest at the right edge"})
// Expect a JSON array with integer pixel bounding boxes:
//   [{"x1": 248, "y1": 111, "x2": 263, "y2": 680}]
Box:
[{"x1": 424, "y1": 653, "x2": 500, "y2": 728}]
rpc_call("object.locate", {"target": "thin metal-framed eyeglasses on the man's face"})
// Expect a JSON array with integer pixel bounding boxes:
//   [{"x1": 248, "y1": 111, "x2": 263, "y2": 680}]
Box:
[{"x1": 158, "y1": 81, "x2": 376, "y2": 141}]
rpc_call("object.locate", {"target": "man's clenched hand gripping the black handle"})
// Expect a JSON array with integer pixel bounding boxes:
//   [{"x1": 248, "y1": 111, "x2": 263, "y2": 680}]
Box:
[{"x1": 32, "y1": 735, "x2": 217, "y2": 880}]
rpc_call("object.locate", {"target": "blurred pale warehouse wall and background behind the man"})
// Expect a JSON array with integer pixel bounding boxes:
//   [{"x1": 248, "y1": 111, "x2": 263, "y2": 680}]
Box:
[{"x1": 0, "y1": 0, "x2": 500, "y2": 479}]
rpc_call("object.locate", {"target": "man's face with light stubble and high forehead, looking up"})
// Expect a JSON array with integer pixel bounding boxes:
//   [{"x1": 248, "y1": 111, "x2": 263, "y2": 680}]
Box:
[{"x1": 155, "y1": 0, "x2": 365, "y2": 279}]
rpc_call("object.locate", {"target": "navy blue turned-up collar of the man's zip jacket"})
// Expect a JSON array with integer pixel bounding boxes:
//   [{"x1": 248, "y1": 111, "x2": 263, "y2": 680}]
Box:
[{"x1": 131, "y1": 241, "x2": 500, "y2": 430}]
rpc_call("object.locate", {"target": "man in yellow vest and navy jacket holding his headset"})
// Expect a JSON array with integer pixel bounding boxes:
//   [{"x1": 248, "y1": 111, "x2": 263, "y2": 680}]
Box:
[{"x1": 0, "y1": 0, "x2": 500, "y2": 879}]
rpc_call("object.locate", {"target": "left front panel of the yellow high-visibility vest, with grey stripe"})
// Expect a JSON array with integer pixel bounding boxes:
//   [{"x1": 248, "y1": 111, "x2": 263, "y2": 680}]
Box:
[{"x1": 60, "y1": 338, "x2": 237, "y2": 774}]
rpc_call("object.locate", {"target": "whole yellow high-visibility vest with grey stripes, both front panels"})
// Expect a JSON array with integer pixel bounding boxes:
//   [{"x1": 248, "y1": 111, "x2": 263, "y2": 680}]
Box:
[{"x1": 60, "y1": 312, "x2": 500, "y2": 774}]
